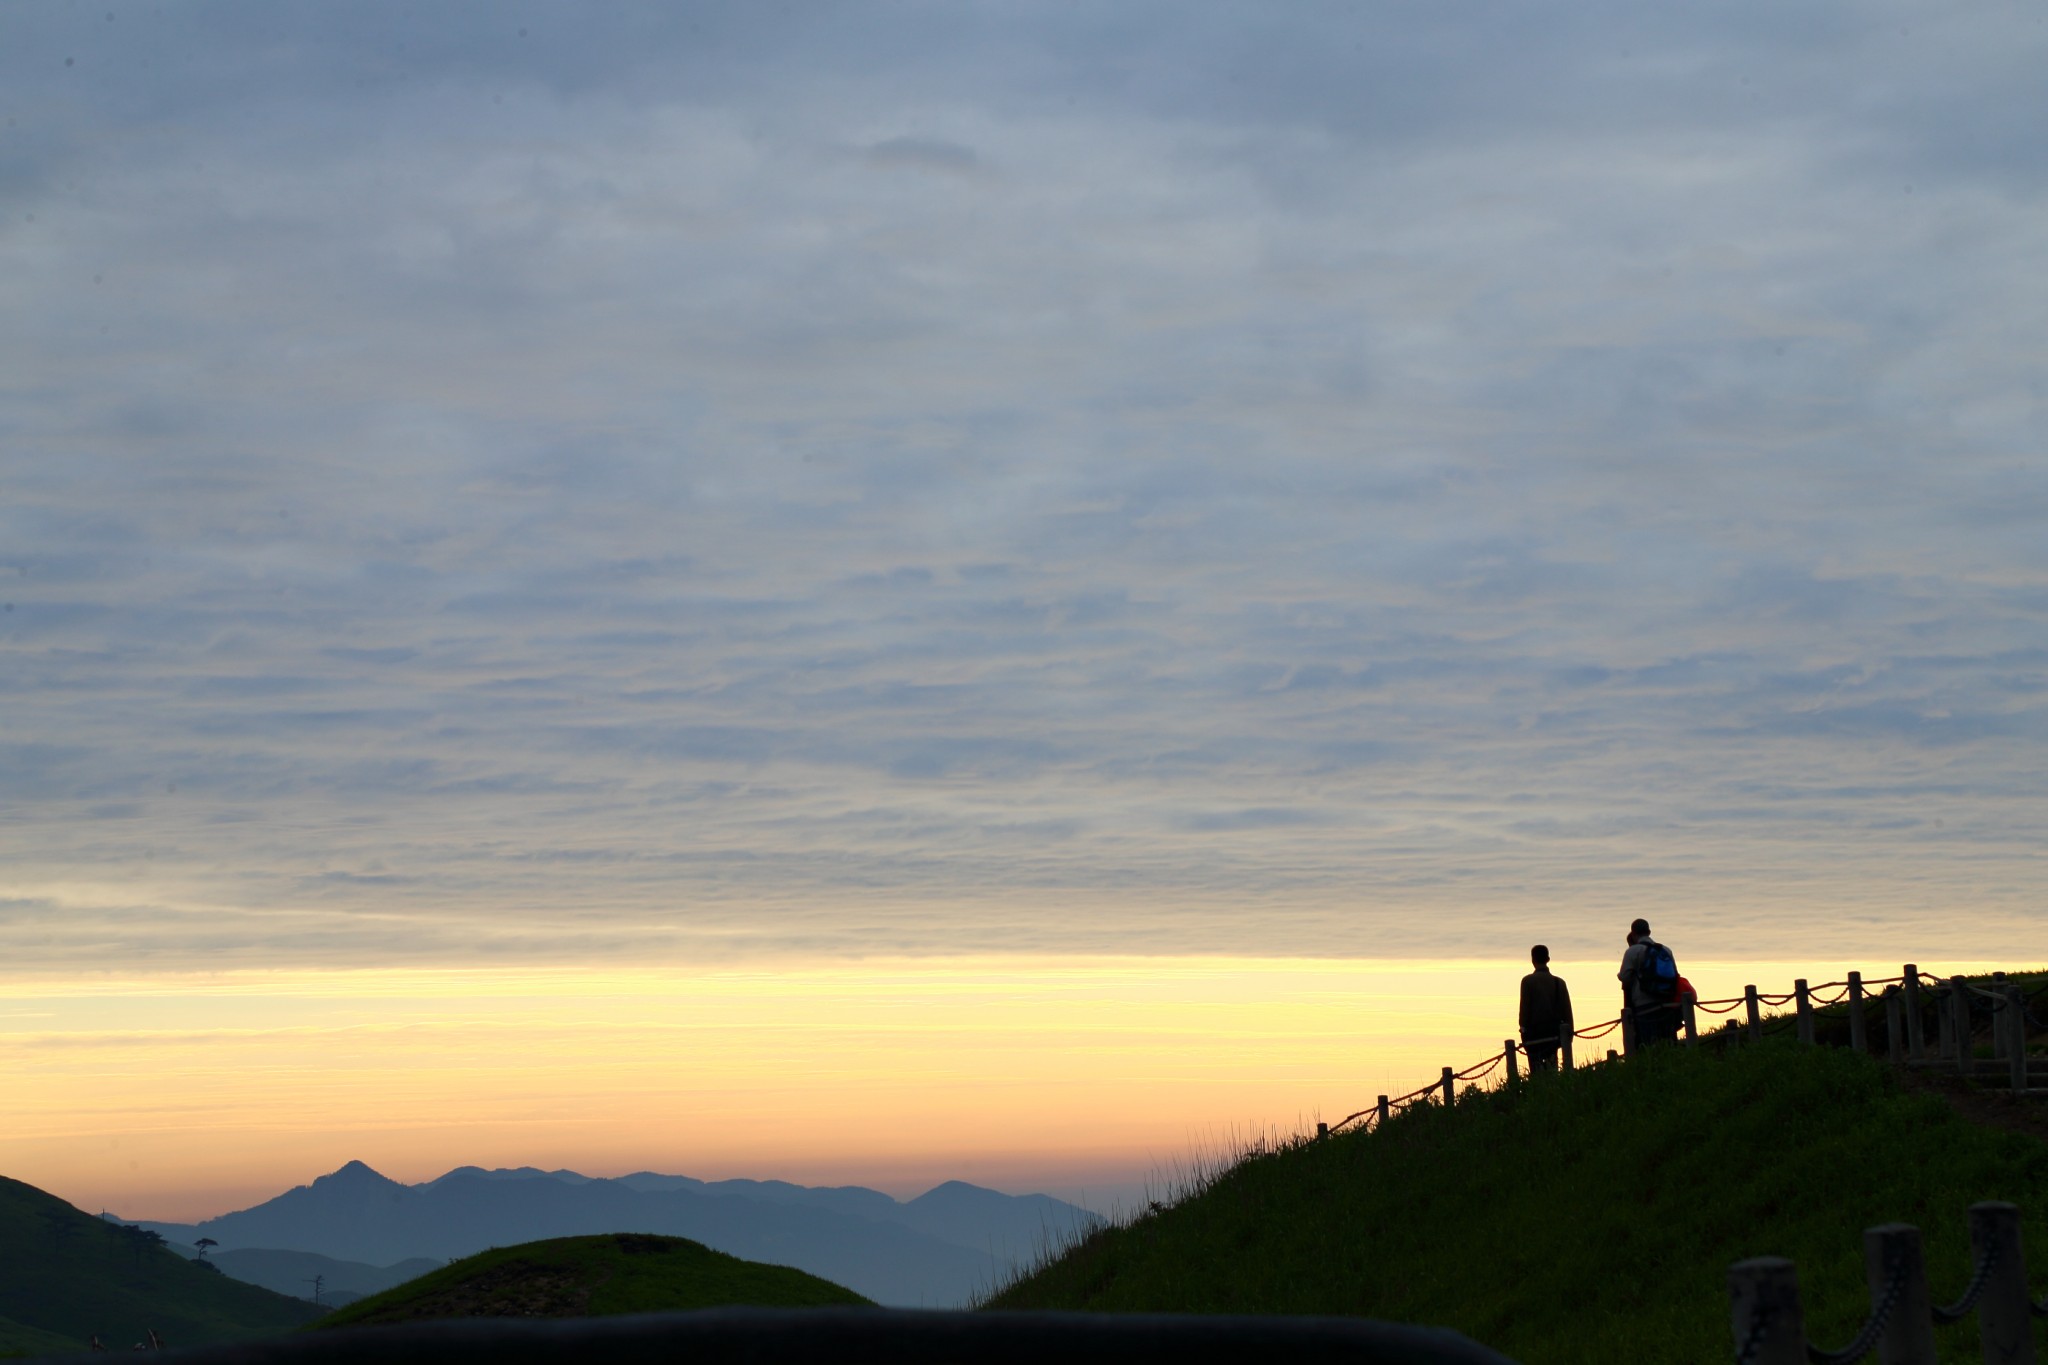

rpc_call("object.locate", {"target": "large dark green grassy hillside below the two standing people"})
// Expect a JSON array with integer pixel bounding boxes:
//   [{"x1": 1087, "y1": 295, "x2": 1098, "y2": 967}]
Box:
[{"x1": 987, "y1": 1042, "x2": 2048, "y2": 1365}]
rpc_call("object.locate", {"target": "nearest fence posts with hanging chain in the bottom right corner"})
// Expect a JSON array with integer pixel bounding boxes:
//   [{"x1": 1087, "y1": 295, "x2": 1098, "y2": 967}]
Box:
[{"x1": 1729, "y1": 1201, "x2": 2048, "y2": 1365}]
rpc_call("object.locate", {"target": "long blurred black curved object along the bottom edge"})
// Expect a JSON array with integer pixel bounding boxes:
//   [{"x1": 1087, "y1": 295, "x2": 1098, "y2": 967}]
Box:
[{"x1": 36, "y1": 1308, "x2": 1513, "y2": 1365}]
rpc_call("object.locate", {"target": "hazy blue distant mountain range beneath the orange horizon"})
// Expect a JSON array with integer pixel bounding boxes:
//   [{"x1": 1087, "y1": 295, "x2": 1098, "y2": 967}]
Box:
[{"x1": 141, "y1": 1160, "x2": 1102, "y2": 1308}]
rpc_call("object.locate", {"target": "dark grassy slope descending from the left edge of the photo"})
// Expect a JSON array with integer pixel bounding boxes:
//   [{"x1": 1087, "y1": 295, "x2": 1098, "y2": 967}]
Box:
[{"x1": 0, "y1": 1177, "x2": 317, "y2": 1353}]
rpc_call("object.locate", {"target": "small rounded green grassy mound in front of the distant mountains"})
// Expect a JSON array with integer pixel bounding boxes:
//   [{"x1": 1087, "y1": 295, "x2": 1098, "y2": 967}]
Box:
[{"x1": 317, "y1": 1232, "x2": 868, "y2": 1328}]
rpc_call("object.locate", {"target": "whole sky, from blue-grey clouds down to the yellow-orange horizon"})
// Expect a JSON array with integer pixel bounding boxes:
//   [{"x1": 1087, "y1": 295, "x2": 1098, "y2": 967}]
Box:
[{"x1": 0, "y1": 0, "x2": 2048, "y2": 1214}]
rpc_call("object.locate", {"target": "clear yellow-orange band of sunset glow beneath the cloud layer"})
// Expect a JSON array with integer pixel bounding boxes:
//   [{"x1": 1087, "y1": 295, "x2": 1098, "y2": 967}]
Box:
[{"x1": 0, "y1": 958, "x2": 1978, "y2": 1220}]
